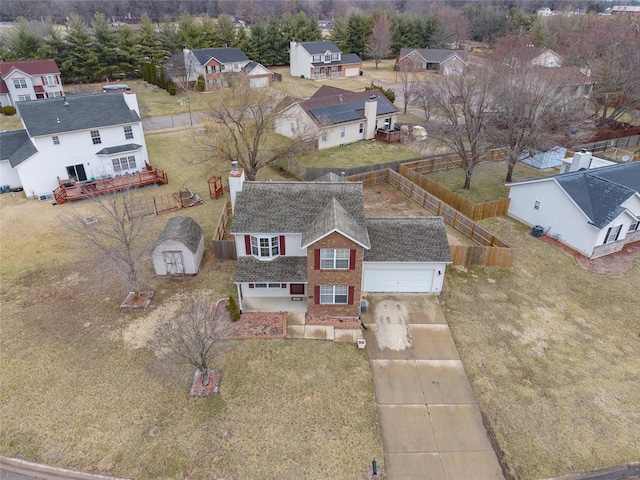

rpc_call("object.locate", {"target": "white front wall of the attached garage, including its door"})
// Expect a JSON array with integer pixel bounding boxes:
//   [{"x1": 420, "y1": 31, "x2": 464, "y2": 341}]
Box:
[{"x1": 362, "y1": 263, "x2": 442, "y2": 293}]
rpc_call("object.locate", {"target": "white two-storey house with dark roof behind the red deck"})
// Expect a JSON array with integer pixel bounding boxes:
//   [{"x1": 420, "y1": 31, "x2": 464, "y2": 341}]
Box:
[{"x1": 0, "y1": 93, "x2": 148, "y2": 200}]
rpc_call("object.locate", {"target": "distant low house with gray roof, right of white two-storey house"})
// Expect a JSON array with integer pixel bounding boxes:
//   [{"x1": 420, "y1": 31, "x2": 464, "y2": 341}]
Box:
[{"x1": 397, "y1": 48, "x2": 469, "y2": 75}]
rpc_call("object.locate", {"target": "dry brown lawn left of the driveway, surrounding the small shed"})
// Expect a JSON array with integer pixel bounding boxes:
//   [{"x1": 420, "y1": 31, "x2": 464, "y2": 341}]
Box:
[{"x1": 0, "y1": 131, "x2": 383, "y2": 479}]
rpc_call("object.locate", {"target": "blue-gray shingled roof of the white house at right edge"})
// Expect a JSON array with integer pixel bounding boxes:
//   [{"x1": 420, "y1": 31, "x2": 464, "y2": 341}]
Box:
[{"x1": 553, "y1": 162, "x2": 640, "y2": 228}]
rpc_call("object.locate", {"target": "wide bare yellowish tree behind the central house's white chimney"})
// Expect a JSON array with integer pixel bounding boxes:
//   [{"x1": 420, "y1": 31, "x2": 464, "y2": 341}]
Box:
[{"x1": 193, "y1": 74, "x2": 311, "y2": 180}]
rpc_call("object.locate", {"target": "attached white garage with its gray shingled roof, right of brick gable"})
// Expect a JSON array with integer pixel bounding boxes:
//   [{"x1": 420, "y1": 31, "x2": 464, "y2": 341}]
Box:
[{"x1": 362, "y1": 217, "x2": 451, "y2": 293}]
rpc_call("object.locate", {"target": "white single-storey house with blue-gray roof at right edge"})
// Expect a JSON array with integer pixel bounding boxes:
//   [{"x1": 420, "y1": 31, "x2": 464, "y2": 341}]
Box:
[{"x1": 508, "y1": 152, "x2": 640, "y2": 258}]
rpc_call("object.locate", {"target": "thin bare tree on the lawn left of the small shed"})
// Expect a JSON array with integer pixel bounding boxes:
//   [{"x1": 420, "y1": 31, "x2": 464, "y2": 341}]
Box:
[{"x1": 67, "y1": 190, "x2": 148, "y2": 293}]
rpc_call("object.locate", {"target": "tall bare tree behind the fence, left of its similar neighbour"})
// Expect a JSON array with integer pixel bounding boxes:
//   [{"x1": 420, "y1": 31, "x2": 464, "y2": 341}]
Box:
[{"x1": 424, "y1": 70, "x2": 494, "y2": 190}]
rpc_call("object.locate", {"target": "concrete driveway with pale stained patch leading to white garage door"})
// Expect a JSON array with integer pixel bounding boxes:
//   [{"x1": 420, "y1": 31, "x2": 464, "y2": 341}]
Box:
[{"x1": 362, "y1": 294, "x2": 504, "y2": 480}]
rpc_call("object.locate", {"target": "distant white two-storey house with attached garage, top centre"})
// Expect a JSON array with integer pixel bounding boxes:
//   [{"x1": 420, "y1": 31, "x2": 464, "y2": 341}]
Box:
[{"x1": 289, "y1": 40, "x2": 362, "y2": 80}]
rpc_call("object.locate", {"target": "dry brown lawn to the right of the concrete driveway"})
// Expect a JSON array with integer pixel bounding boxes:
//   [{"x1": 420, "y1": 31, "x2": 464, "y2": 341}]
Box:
[{"x1": 443, "y1": 218, "x2": 640, "y2": 480}]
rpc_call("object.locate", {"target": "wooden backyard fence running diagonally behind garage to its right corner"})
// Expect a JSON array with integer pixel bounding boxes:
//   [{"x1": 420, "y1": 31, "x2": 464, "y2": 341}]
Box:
[{"x1": 348, "y1": 169, "x2": 515, "y2": 268}]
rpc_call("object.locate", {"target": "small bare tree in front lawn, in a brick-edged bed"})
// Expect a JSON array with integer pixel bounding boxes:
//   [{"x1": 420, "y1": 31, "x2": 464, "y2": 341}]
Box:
[{"x1": 154, "y1": 295, "x2": 230, "y2": 386}]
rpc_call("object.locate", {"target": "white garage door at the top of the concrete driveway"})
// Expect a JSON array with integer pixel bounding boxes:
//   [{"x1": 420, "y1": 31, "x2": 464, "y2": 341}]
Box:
[{"x1": 363, "y1": 268, "x2": 434, "y2": 293}]
